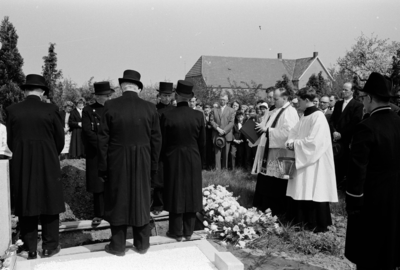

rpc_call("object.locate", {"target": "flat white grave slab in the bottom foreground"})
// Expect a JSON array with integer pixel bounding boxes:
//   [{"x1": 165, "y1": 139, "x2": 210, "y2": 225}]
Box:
[{"x1": 16, "y1": 239, "x2": 244, "y2": 270}]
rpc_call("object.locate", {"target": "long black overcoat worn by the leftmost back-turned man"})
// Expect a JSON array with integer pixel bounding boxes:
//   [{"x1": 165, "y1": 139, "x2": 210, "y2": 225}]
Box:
[{"x1": 6, "y1": 96, "x2": 65, "y2": 216}]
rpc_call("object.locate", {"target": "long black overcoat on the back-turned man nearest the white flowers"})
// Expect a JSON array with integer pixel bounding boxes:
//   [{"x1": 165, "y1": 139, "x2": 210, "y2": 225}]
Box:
[{"x1": 161, "y1": 102, "x2": 205, "y2": 213}]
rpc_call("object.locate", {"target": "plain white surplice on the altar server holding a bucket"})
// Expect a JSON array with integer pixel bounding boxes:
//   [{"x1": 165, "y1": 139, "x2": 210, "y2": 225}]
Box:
[{"x1": 286, "y1": 108, "x2": 338, "y2": 202}]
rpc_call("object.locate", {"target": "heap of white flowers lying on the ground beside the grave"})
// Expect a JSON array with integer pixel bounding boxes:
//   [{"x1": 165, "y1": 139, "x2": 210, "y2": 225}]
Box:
[{"x1": 203, "y1": 185, "x2": 282, "y2": 248}]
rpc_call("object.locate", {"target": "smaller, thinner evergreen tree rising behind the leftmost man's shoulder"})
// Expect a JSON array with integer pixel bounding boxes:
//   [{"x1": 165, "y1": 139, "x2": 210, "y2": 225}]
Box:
[{"x1": 42, "y1": 43, "x2": 62, "y2": 100}]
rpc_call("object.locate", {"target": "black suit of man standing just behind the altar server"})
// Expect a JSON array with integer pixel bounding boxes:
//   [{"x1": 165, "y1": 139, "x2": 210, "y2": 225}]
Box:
[{"x1": 329, "y1": 99, "x2": 364, "y2": 188}]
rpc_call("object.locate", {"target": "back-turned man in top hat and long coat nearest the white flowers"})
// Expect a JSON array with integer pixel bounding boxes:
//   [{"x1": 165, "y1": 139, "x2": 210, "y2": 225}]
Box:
[{"x1": 161, "y1": 80, "x2": 205, "y2": 241}]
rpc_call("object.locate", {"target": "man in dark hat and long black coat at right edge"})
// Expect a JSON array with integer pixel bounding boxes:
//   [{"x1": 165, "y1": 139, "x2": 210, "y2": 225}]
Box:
[{"x1": 345, "y1": 72, "x2": 400, "y2": 270}]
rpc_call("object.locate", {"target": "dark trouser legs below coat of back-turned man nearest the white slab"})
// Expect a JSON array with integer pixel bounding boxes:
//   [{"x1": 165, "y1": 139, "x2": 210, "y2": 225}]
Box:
[{"x1": 110, "y1": 224, "x2": 150, "y2": 252}]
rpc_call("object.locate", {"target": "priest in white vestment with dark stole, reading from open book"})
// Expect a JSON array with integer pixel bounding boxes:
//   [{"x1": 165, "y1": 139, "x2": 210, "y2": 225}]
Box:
[{"x1": 252, "y1": 88, "x2": 299, "y2": 216}]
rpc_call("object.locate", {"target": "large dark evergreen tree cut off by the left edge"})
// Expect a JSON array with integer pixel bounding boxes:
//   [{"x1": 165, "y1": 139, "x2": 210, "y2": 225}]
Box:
[{"x1": 0, "y1": 16, "x2": 25, "y2": 108}]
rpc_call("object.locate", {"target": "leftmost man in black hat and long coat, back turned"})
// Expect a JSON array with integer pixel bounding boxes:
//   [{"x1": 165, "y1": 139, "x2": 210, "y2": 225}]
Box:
[{"x1": 6, "y1": 74, "x2": 65, "y2": 259}]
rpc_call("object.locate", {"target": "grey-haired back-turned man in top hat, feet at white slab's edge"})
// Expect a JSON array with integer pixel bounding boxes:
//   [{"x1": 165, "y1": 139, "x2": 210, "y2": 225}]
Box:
[{"x1": 98, "y1": 70, "x2": 161, "y2": 256}]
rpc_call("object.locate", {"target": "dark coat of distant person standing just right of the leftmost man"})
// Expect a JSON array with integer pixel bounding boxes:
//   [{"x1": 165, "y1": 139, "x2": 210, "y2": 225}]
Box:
[{"x1": 68, "y1": 108, "x2": 85, "y2": 158}]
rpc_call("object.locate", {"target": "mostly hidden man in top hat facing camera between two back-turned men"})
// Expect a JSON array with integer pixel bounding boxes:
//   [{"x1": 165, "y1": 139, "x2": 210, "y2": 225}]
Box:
[{"x1": 151, "y1": 82, "x2": 175, "y2": 215}]
